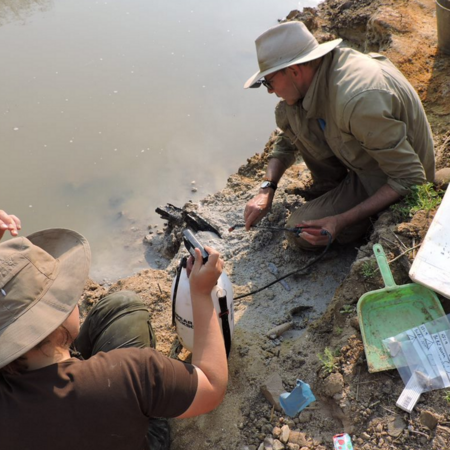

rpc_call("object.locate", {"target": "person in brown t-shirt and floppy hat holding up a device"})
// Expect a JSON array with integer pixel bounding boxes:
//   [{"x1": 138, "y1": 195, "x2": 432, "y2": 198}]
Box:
[{"x1": 0, "y1": 229, "x2": 228, "y2": 450}]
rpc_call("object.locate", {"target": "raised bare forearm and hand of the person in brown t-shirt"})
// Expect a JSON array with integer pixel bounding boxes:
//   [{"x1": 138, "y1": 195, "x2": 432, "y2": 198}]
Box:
[{"x1": 179, "y1": 247, "x2": 228, "y2": 418}]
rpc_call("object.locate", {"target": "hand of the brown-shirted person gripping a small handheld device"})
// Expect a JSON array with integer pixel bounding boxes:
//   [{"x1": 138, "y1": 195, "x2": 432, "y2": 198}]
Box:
[{"x1": 189, "y1": 246, "x2": 223, "y2": 297}]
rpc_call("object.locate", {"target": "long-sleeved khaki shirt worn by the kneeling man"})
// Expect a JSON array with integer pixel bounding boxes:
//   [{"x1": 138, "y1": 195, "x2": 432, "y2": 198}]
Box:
[{"x1": 271, "y1": 48, "x2": 435, "y2": 195}]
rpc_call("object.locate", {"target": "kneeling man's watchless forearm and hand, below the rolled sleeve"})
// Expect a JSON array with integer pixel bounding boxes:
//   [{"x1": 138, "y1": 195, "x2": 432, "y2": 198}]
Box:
[{"x1": 297, "y1": 184, "x2": 401, "y2": 245}]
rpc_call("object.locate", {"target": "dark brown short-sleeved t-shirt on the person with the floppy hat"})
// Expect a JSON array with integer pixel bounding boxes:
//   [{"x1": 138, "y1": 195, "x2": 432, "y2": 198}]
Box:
[{"x1": 0, "y1": 348, "x2": 197, "y2": 450}]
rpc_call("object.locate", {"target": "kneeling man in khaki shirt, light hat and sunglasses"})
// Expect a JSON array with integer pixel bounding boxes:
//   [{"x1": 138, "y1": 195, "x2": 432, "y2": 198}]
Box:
[{"x1": 244, "y1": 22, "x2": 435, "y2": 249}]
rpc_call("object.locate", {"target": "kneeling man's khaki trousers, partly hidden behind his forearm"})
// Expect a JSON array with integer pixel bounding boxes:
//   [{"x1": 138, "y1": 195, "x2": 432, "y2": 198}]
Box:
[{"x1": 286, "y1": 172, "x2": 370, "y2": 250}]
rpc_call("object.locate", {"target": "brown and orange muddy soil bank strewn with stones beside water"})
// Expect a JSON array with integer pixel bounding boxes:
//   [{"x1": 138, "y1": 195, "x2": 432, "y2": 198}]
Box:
[{"x1": 83, "y1": 0, "x2": 450, "y2": 450}]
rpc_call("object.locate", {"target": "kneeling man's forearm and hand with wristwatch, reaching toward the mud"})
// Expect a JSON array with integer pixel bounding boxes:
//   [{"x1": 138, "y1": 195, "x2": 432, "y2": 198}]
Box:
[{"x1": 244, "y1": 158, "x2": 286, "y2": 231}]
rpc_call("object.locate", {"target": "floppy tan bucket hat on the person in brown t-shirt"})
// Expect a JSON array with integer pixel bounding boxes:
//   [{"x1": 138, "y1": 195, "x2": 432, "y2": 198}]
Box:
[{"x1": 0, "y1": 228, "x2": 91, "y2": 368}]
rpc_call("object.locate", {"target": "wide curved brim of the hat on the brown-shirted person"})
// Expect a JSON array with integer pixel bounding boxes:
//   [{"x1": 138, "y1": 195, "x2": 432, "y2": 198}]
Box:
[{"x1": 0, "y1": 228, "x2": 91, "y2": 368}]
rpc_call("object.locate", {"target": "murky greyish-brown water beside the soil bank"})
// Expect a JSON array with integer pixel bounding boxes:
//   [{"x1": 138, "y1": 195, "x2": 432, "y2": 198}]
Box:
[{"x1": 0, "y1": 0, "x2": 318, "y2": 280}]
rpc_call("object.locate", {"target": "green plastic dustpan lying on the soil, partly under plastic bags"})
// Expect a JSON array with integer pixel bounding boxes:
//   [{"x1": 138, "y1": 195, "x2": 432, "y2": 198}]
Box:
[{"x1": 357, "y1": 244, "x2": 445, "y2": 373}]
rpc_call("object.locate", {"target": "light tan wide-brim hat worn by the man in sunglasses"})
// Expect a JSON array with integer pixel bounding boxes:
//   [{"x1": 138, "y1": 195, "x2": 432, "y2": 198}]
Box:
[{"x1": 244, "y1": 21, "x2": 342, "y2": 89}]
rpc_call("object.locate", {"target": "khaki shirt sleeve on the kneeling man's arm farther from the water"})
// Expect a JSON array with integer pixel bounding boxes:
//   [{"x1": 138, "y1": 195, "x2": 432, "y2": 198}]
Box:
[{"x1": 341, "y1": 89, "x2": 426, "y2": 195}]
